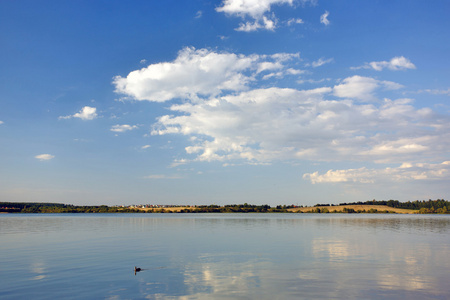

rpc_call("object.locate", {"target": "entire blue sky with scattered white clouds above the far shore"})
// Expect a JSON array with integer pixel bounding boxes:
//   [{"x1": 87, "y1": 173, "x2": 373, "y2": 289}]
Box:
[{"x1": 0, "y1": 0, "x2": 450, "y2": 205}]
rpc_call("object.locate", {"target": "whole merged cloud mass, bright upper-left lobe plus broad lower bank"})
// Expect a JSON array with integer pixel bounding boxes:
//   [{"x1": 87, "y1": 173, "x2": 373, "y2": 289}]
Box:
[{"x1": 115, "y1": 48, "x2": 450, "y2": 166}]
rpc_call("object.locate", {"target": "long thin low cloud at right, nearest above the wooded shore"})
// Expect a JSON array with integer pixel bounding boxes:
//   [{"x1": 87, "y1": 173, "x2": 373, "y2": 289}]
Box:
[{"x1": 303, "y1": 161, "x2": 450, "y2": 184}]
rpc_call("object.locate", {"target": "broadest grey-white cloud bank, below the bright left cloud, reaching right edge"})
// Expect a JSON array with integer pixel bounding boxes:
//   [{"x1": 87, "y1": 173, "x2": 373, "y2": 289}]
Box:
[{"x1": 152, "y1": 82, "x2": 450, "y2": 163}]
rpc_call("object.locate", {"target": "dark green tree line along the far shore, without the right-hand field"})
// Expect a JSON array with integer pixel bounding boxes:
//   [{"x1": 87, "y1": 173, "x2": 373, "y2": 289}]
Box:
[{"x1": 0, "y1": 199, "x2": 450, "y2": 214}]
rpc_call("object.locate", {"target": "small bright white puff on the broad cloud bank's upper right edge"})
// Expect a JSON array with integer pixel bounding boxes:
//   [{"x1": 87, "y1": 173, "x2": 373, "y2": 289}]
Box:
[{"x1": 334, "y1": 75, "x2": 402, "y2": 101}]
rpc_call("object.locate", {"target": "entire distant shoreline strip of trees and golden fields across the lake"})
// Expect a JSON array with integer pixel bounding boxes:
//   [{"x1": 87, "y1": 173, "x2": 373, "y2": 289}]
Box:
[{"x1": 0, "y1": 199, "x2": 450, "y2": 214}]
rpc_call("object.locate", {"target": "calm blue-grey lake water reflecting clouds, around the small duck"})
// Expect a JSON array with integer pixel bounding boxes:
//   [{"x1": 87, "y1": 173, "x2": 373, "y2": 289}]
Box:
[{"x1": 0, "y1": 214, "x2": 450, "y2": 299}]
